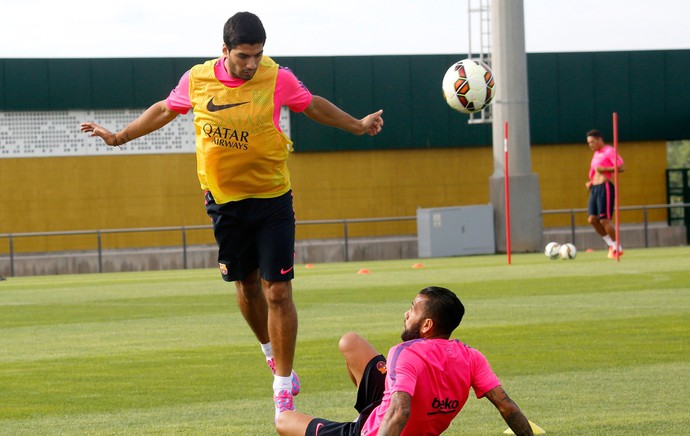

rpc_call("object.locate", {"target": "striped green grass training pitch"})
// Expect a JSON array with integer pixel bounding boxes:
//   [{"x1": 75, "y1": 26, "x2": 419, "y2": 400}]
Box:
[{"x1": 0, "y1": 247, "x2": 690, "y2": 435}]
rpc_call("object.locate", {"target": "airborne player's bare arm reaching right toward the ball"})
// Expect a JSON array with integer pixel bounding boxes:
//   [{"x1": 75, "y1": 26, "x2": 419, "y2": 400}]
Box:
[{"x1": 304, "y1": 95, "x2": 383, "y2": 136}]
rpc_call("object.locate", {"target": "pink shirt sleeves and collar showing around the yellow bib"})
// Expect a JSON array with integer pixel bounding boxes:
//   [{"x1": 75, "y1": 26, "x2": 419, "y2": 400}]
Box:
[{"x1": 165, "y1": 57, "x2": 312, "y2": 130}]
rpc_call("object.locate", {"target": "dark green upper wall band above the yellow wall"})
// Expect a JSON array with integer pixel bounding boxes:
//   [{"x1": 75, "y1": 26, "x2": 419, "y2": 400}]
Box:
[{"x1": 0, "y1": 50, "x2": 690, "y2": 151}]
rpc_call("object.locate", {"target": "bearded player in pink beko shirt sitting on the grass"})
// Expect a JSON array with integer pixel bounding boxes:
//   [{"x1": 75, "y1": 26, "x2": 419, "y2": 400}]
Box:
[{"x1": 276, "y1": 287, "x2": 533, "y2": 436}]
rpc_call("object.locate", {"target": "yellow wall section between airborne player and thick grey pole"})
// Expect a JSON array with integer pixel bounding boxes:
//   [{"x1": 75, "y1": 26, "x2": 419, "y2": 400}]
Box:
[{"x1": 290, "y1": 148, "x2": 493, "y2": 238}]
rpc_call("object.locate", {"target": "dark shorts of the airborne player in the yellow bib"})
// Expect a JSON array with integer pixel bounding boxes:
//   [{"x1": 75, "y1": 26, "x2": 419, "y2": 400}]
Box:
[{"x1": 205, "y1": 191, "x2": 295, "y2": 282}]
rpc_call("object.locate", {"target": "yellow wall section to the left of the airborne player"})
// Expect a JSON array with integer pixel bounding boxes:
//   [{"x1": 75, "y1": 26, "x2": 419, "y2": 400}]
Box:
[{"x1": 0, "y1": 154, "x2": 213, "y2": 253}]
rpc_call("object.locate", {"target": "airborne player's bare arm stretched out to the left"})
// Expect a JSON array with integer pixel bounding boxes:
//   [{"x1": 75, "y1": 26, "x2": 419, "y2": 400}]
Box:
[{"x1": 80, "y1": 100, "x2": 179, "y2": 146}]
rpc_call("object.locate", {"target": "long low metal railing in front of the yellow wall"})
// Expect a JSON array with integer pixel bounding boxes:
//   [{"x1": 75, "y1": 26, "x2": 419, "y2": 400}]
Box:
[{"x1": 0, "y1": 203, "x2": 690, "y2": 276}]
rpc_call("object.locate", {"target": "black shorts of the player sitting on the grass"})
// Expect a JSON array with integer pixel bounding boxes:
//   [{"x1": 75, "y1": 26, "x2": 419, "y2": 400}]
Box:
[{"x1": 305, "y1": 354, "x2": 386, "y2": 436}]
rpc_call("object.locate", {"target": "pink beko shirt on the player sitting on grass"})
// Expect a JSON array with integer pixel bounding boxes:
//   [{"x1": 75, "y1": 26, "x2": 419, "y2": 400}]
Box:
[{"x1": 361, "y1": 339, "x2": 501, "y2": 436}]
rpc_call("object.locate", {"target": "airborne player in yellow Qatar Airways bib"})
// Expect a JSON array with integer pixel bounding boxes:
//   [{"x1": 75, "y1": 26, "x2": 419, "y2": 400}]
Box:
[{"x1": 81, "y1": 12, "x2": 383, "y2": 424}]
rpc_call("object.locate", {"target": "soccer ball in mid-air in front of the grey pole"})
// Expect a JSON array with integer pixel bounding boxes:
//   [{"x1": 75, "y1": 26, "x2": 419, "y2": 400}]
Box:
[{"x1": 441, "y1": 59, "x2": 496, "y2": 114}]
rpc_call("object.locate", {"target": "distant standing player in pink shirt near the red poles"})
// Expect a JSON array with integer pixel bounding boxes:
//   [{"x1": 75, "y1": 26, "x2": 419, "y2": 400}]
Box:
[{"x1": 585, "y1": 130, "x2": 625, "y2": 259}]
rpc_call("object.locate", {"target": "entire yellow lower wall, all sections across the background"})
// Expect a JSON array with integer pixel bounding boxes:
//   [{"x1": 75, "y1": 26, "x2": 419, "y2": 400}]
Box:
[{"x1": 0, "y1": 141, "x2": 666, "y2": 252}]
